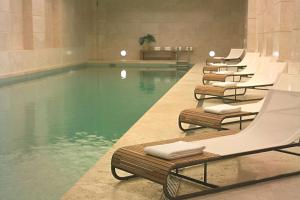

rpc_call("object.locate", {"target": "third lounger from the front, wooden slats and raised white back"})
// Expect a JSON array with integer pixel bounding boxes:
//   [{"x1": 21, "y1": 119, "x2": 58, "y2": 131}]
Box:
[{"x1": 194, "y1": 62, "x2": 286, "y2": 102}]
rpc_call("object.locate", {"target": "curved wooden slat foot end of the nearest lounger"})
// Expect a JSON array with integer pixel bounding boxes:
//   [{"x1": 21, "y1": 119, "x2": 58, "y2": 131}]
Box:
[{"x1": 111, "y1": 130, "x2": 236, "y2": 199}]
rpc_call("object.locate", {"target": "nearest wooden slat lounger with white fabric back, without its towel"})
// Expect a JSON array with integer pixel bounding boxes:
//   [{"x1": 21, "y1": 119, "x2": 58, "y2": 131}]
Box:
[{"x1": 111, "y1": 90, "x2": 300, "y2": 199}]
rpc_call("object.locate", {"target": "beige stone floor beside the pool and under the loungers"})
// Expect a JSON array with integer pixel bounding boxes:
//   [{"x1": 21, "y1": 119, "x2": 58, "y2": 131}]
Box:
[{"x1": 62, "y1": 64, "x2": 300, "y2": 200}]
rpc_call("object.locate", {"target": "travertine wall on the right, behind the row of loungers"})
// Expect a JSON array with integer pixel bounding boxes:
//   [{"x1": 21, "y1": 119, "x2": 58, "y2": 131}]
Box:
[{"x1": 247, "y1": 0, "x2": 300, "y2": 73}]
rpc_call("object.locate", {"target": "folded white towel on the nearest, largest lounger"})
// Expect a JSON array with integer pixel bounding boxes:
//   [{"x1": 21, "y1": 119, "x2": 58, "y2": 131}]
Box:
[{"x1": 144, "y1": 141, "x2": 205, "y2": 160}]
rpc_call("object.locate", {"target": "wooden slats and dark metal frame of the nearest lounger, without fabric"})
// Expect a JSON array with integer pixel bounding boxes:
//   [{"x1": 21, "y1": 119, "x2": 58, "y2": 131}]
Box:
[{"x1": 111, "y1": 131, "x2": 300, "y2": 200}]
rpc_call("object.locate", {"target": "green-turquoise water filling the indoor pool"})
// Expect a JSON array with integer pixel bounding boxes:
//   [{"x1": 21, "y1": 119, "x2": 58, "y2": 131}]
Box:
[{"x1": 0, "y1": 66, "x2": 186, "y2": 200}]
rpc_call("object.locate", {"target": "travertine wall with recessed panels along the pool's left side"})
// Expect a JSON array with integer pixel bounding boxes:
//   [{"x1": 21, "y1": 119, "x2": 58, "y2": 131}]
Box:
[{"x1": 0, "y1": 0, "x2": 92, "y2": 77}]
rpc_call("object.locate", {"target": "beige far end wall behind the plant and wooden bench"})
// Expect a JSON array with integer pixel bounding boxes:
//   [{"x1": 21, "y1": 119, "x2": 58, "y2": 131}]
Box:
[{"x1": 90, "y1": 0, "x2": 247, "y2": 62}]
